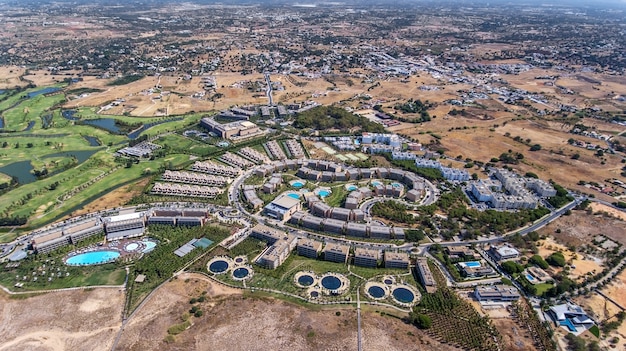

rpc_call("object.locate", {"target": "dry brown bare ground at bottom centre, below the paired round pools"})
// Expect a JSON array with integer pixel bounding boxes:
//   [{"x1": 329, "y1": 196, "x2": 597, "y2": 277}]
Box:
[{"x1": 118, "y1": 275, "x2": 454, "y2": 351}]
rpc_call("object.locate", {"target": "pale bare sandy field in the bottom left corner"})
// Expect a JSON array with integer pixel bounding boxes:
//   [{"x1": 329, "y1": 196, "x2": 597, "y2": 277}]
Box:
[{"x1": 0, "y1": 289, "x2": 124, "y2": 351}]
